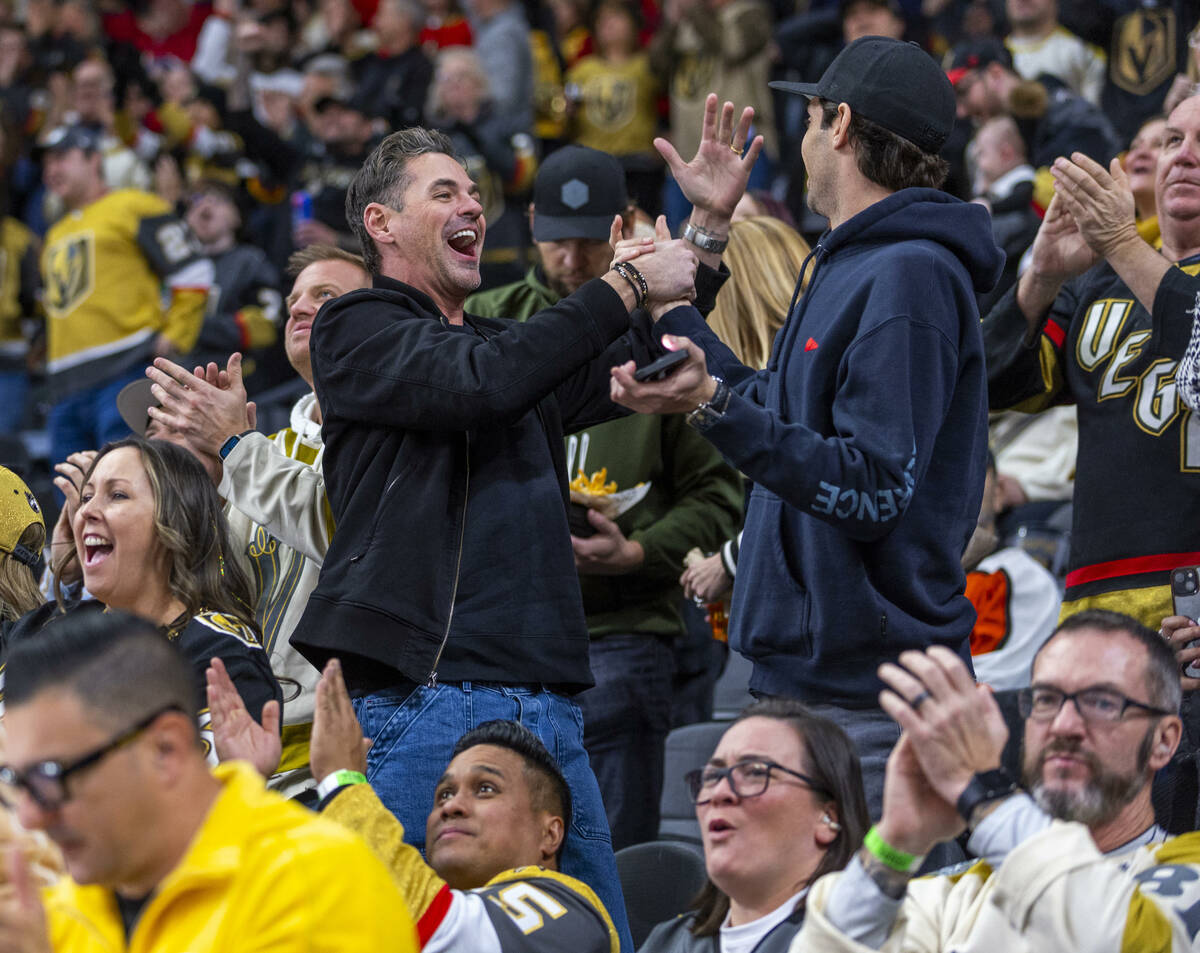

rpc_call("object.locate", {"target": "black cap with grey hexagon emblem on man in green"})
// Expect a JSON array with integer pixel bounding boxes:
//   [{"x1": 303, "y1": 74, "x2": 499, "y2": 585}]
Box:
[{"x1": 533, "y1": 145, "x2": 629, "y2": 241}]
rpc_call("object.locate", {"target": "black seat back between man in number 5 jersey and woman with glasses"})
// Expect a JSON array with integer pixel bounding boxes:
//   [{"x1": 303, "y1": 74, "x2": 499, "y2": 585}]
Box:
[{"x1": 617, "y1": 840, "x2": 707, "y2": 947}]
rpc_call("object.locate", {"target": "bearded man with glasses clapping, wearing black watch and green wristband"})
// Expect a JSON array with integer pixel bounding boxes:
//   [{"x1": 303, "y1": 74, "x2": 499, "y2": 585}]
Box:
[{"x1": 792, "y1": 610, "x2": 1200, "y2": 953}]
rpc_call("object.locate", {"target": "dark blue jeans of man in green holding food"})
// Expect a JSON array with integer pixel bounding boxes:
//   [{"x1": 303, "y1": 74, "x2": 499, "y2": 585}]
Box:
[{"x1": 577, "y1": 635, "x2": 674, "y2": 850}]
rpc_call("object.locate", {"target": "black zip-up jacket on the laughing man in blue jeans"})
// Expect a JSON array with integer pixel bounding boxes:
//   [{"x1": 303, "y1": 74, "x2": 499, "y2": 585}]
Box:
[{"x1": 292, "y1": 271, "x2": 659, "y2": 691}]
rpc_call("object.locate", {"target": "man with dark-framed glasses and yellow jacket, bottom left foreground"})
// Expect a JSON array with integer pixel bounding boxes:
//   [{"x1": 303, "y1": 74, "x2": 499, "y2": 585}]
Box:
[{"x1": 0, "y1": 611, "x2": 416, "y2": 953}]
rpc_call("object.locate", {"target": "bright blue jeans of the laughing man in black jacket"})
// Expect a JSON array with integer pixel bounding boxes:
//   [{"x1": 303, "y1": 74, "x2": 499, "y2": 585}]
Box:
[{"x1": 353, "y1": 682, "x2": 634, "y2": 953}]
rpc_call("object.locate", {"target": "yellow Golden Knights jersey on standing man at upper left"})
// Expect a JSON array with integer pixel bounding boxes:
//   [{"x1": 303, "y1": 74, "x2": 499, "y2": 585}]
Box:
[{"x1": 42, "y1": 188, "x2": 212, "y2": 397}]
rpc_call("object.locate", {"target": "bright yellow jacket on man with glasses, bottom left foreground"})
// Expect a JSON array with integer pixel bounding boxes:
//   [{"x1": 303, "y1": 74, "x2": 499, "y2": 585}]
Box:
[{"x1": 44, "y1": 762, "x2": 416, "y2": 953}]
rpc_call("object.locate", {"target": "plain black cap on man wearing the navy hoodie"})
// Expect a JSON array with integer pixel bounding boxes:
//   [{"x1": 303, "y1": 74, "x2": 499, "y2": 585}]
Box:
[{"x1": 768, "y1": 36, "x2": 956, "y2": 154}]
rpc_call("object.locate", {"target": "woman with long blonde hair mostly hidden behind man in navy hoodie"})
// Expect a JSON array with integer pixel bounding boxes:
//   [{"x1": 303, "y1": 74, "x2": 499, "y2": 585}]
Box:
[{"x1": 679, "y1": 215, "x2": 811, "y2": 604}]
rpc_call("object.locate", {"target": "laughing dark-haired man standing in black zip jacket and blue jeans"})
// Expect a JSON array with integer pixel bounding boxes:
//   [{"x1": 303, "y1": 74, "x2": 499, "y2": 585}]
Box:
[{"x1": 292, "y1": 128, "x2": 696, "y2": 947}]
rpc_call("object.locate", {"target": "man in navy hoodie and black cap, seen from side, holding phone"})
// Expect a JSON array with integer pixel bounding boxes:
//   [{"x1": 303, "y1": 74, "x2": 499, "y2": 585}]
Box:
[{"x1": 612, "y1": 37, "x2": 1003, "y2": 816}]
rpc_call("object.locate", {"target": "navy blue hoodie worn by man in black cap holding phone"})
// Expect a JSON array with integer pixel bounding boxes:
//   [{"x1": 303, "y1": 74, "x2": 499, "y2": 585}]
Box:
[{"x1": 659, "y1": 188, "x2": 1003, "y2": 707}]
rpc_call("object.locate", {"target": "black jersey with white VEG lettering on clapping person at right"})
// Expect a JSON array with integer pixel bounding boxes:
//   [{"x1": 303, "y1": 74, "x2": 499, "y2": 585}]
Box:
[{"x1": 983, "y1": 258, "x2": 1200, "y2": 629}]
